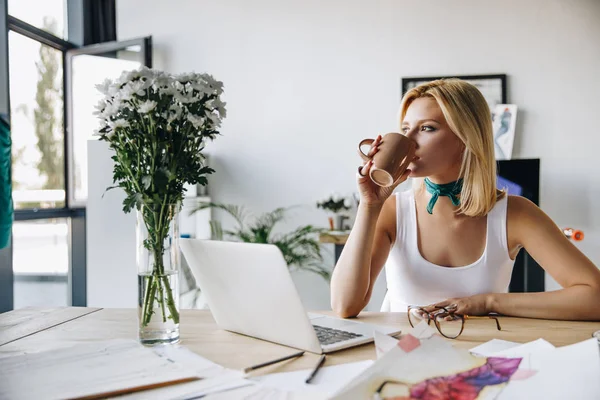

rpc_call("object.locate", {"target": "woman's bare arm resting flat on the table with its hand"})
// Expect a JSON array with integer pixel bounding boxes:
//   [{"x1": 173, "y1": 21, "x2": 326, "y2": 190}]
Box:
[{"x1": 436, "y1": 196, "x2": 600, "y2": 321}]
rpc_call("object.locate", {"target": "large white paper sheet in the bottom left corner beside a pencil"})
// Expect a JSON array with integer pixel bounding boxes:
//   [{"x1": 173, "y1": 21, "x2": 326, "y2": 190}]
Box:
[{"x1": 0, "y1": 340, "x2": 202, "y2": 400}]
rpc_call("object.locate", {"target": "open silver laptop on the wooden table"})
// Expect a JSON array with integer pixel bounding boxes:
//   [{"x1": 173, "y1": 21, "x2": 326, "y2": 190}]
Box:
[{"x1": 180, "y1": 239, "x2": 400, "y2": 354}]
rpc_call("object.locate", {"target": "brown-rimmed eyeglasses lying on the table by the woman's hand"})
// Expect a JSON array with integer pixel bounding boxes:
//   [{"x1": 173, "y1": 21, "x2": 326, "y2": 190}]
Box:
[{"x1": 408, "y1": 306, "x2": 502, "y2": 339}]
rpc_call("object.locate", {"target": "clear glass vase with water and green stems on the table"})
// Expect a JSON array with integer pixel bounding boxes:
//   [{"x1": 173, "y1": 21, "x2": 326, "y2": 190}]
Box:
[{"x1": 136, "y1": 204, "x2": 181, "y2": 346}]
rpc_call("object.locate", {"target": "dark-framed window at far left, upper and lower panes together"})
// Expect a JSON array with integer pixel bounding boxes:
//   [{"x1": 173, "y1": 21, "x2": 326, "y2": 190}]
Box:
[{"x1": 2, "y1": 7, "x2": 86, "y2": 308}]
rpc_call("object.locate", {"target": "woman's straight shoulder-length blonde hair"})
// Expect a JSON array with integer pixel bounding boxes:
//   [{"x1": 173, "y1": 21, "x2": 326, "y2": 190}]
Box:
[{"x1": 400, "y1": 79, "x2": 506, "y2": 217}]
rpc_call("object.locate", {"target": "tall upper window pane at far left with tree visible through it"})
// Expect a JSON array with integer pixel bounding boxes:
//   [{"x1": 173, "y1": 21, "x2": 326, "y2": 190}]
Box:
[{"x1": 9, "y1": 32, "x2": 65, "y2": 209}]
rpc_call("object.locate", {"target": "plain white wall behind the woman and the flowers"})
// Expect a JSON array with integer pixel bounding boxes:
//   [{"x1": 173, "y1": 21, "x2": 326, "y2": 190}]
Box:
[{"x1": 117, "y1": 0, "x2": 600, "y2": 308}]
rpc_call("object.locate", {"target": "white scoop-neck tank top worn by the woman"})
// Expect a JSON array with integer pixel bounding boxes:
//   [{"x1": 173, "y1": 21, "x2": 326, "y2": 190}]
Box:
[{"x1": 381, "y1": 190, "x2": 514, "y2": 312}]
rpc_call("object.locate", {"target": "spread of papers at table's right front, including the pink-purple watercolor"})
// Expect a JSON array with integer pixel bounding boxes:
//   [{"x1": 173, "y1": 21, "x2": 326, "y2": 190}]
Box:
[{"x1": 332, "y1": 323, "x2": 600, "y2": 400}]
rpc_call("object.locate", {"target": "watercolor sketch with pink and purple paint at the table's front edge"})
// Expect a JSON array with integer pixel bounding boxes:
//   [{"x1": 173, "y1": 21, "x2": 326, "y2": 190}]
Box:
[{"x1": 333, "y1": 330, "x2": 522, "y2": 400}]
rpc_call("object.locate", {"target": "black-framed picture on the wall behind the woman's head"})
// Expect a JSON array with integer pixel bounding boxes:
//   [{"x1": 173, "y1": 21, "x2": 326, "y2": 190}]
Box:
[{"x1": 401, "y1": 74, "x2": 508, "y2": 112}]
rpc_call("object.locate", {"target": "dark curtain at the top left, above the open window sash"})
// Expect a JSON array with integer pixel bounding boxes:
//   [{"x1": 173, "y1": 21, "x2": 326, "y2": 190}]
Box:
[{"x1": 83, "y1": 0, "x2": 117, "y2": 45}]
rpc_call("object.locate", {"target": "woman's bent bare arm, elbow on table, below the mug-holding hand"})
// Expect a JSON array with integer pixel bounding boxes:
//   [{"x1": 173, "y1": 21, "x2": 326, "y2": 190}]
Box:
[{"x1": 331, "y1": 196, "x2": 396, "y2": 318}]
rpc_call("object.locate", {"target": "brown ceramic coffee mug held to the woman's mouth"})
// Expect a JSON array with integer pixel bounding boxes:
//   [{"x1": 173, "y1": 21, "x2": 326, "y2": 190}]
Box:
[{"x1": 358, "y1": 132, "x2": 417, "y2": 187}]
